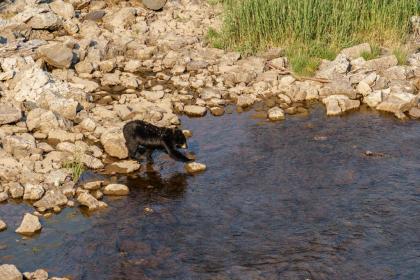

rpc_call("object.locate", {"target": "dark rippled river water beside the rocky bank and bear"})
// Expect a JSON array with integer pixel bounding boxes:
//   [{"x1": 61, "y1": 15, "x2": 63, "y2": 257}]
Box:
[{"x1": 0, "y1": 107, "x2": 420, "y2": 280}]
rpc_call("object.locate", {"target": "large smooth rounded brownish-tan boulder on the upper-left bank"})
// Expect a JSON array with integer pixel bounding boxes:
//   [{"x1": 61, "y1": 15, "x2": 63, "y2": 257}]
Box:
[{"x1": 38, "y1": 43, "x2": 73, "y2": 69}]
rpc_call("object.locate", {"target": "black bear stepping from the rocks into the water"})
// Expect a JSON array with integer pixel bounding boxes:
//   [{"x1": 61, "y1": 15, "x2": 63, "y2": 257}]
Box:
[{"x1": 123, "y1": 120, "x2": 193, "y2": 162}]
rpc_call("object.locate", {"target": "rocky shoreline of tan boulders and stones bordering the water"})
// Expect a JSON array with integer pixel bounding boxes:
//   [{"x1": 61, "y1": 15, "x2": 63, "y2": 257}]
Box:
[{"x1": 0, "y1": 0, "x2": 420, "y2": 279}]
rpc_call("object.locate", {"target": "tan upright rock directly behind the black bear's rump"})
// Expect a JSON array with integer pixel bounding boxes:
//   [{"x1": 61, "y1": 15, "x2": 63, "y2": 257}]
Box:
[{"x1": 101, "y1": 128, "x2": 128, "y2": 159}]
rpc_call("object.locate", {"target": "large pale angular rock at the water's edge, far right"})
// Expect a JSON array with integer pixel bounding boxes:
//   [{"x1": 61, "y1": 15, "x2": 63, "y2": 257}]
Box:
[{"x1": 376, "y1": 92, "x2": 415, "y2": 118}]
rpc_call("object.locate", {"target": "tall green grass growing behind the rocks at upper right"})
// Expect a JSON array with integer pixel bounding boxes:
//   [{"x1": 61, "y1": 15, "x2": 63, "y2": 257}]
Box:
[{"x1": 212, "y1": 0, "x2": 420, "y2": 74}]
